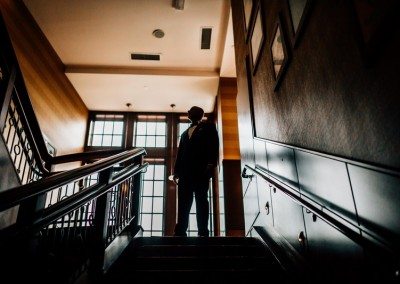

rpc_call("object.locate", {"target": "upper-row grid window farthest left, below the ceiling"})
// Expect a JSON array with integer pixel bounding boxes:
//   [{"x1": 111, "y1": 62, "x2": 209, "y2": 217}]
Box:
[{"x1": 88, "y1": 114, "x2": 124, "y2": 147}]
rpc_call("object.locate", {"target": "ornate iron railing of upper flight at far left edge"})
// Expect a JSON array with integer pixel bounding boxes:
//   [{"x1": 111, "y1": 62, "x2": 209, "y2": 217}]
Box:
[{"x1": 0, "y1": 66, "x2": 51, "y2": 184}]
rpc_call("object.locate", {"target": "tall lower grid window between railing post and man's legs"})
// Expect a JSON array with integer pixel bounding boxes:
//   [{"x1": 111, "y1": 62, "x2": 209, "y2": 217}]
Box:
[{"x1": 139, "y1": 159, "x2": 166, "y2": 236}]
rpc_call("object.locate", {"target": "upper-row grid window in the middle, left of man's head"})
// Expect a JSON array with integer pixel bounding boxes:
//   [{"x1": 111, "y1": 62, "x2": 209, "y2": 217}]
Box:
[{"x1": 134, "y1": 115, "x2": 167, "y2": 148}]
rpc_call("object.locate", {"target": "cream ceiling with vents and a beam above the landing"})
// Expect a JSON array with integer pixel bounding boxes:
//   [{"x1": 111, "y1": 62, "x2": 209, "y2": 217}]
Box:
[{"x1": 24, "y1": 0, "x2": 236, "y2": 112}]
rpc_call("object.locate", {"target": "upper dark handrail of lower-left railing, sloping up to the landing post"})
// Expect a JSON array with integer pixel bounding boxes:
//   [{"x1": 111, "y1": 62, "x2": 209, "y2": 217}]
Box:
[{"x1": 0, "y1": 148, "x2": 146, "y2": 212}]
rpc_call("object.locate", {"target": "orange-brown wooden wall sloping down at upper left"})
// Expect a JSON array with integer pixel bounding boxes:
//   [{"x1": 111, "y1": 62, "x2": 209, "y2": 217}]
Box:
[{"x1": 0, "y1": 0, "x2": 88, "y2": 154}]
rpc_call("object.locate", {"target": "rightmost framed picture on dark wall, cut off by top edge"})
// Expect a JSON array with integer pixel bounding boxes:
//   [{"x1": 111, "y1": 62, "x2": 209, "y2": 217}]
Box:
[{"x1": 287, "y1": 0, "x2": 313, "y2": 47}]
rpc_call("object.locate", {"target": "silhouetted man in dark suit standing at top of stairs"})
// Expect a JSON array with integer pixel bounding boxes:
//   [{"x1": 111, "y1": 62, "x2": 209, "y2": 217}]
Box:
[{"x1": 174, "y1": 106, "x2": 219, "y2": 236}]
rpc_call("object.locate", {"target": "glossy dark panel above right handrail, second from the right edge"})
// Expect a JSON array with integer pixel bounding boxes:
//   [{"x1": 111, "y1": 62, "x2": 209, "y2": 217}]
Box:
[{"x1": 295, "y1": 150, "x2": 357, "y2": 225}]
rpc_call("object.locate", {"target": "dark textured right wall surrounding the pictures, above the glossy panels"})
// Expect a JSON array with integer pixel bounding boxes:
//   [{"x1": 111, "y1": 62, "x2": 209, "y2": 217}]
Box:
[{"x1": 231, "y1": 0, "x2": 400, "y2": 168}]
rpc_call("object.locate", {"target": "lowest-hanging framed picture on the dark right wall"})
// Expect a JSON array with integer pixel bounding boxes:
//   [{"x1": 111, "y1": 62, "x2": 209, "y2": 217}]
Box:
[{"x1": 270, "y1": 15, "x2": 289, "y2": 91}]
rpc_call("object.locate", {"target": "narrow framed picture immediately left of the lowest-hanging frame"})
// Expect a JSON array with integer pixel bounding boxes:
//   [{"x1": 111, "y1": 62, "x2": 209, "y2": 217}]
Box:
[{"x1": 249, "y1": 1, "x2": 265, "y2": 76}]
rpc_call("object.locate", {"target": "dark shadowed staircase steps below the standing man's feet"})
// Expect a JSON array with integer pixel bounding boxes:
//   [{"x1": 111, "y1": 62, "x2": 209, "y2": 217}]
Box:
[{"x1": 102, "y1": 237, "x2": 285, "y2": 283}]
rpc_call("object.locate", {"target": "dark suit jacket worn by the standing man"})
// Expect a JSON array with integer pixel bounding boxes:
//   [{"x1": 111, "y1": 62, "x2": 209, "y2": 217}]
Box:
[{"x1": 174, "y1": 122, "x2": 219, "y2": 180}]
